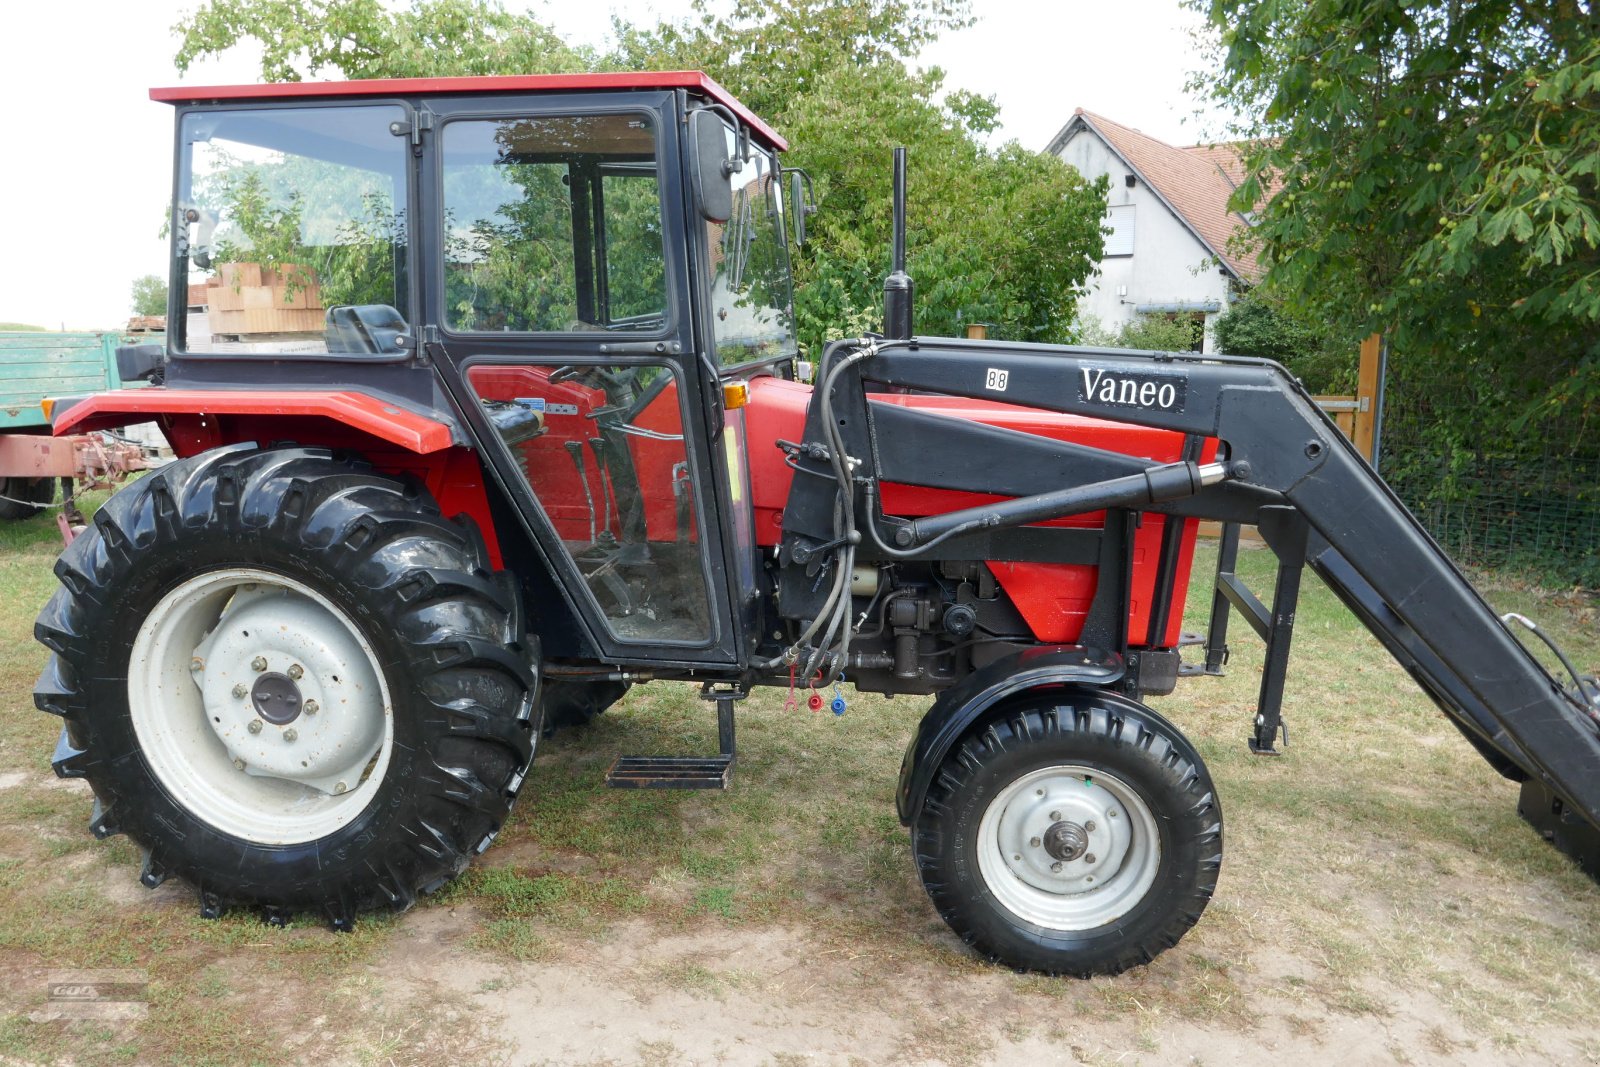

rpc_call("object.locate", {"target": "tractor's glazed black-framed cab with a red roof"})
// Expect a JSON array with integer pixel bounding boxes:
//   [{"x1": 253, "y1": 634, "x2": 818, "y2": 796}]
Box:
[{"x1": 155, "y1": 74, "x2": 797, "y2": 667}]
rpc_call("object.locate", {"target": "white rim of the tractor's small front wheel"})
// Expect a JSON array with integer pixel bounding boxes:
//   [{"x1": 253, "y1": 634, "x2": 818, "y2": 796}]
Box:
[{"x1": 978, "y1": 765, "x2": 1162, "y2": 931}]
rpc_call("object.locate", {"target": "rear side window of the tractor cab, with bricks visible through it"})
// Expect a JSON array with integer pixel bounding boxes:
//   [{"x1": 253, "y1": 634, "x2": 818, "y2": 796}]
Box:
[{"x1": 173, "y1": 106, "x2": 408, "y2": 355}]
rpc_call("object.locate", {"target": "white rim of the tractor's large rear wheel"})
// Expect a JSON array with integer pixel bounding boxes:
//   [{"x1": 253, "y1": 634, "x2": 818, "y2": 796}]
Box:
[{"x1": 128, "y1": 568, "x2": 394, "y2": 845}]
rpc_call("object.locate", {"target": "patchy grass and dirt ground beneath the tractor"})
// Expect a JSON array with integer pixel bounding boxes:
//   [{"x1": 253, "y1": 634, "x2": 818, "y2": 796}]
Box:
[{"x1": 0, "y1": 534, "x2": 1600, "y2": 1067}]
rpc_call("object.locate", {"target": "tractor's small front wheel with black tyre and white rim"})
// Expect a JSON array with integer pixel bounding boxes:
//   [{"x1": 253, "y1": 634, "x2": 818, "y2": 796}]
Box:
[{"x1": 914, "y1": 693, "x2": 1222, "y2": 976}]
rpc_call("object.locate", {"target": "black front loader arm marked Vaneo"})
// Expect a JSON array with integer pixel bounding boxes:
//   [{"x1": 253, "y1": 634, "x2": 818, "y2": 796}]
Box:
[{"x1": 784, "y1": 338, "x2": 1600, "y2": 857}]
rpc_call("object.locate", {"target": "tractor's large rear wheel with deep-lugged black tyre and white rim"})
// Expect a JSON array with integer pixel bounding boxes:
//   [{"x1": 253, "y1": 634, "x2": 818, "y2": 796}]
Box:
[{"x1": 35, "y1": 446, "x2": 534, "y2": 928}]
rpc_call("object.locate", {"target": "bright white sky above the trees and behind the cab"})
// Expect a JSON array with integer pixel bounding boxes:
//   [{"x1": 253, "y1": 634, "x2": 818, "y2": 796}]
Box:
[{"x1": 0, "y1": 0, "x2": 1219, "y2": 330}]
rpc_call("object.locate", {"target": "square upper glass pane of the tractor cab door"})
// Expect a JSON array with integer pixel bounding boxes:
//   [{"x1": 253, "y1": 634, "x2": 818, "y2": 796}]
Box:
[{"x1": 443, "y1": 114, "x2": 667, "y2": 333}]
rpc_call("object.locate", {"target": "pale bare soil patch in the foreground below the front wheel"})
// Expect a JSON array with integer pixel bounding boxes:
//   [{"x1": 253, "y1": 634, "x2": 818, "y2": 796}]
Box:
[{"x1": 374, "y1": 909, "x2": 1597, "y2": 1067}]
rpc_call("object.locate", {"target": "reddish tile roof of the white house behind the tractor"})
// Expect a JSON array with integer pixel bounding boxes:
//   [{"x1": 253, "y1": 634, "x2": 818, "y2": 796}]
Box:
[{"x1": 1050, "y1": 107, "x2": 1261, "y2": 282}]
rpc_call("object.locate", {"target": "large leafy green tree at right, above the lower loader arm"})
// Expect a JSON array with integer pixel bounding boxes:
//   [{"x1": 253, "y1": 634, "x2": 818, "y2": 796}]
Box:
[{"x1": 1190, "y1": 0, "x2": 1600, "y2": 453}]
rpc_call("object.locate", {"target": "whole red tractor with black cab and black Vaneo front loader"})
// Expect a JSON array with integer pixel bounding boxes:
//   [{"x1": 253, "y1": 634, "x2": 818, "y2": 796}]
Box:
[{"x1": 37, "y1": 74, "x2": 1600, "y2": 974}]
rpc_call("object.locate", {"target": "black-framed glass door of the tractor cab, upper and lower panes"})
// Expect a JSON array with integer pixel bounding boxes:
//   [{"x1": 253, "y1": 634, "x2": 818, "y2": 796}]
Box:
[{"x1": 421, "y1": 93, "x2": 742, "y2": 667}]
